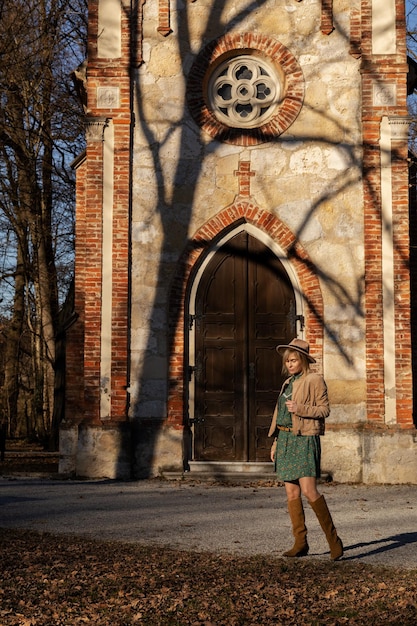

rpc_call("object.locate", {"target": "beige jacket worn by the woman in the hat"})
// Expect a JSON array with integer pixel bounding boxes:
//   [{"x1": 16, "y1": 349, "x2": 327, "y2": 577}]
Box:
[{"x1": 268, "y1": 372, "x2": 330, "y2": 437}]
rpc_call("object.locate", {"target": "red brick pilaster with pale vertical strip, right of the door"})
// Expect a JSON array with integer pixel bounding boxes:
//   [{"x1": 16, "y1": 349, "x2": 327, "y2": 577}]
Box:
[{"x1": 355, "y1": 0, "x2": 412, "y2": 425}]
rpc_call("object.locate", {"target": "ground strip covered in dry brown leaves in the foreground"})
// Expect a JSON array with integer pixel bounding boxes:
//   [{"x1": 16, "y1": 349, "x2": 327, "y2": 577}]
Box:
[{"x1": 0, "y1": 529, "x2": 417, "y2": 626}]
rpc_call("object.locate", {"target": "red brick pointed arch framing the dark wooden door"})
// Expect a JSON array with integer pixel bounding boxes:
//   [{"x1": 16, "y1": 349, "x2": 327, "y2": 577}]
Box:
[{"x1": 167, "y1": 202, "x2": 323, "y2": 428}]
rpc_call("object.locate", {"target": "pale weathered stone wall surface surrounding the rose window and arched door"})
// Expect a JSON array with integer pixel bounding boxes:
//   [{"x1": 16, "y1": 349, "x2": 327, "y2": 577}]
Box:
[{"x1": 132, "y1": 0, "x2": 365, "y2": 434}]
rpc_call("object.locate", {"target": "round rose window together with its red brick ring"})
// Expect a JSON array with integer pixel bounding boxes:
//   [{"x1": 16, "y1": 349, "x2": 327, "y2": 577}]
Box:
[{"x1": 186, "y1": 33, "x2": 304, "y2": 146}]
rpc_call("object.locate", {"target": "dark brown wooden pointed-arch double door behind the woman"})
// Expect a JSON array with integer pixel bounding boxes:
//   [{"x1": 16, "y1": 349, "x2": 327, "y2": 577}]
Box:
[{"x1": 194, "y1": 232, "x2": 296, "y2": 462}]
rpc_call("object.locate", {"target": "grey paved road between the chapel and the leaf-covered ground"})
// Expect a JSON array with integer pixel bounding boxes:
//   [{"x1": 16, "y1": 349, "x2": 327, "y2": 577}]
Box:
[{"x1": 0, "y1": 477, "x2": 417, "y2": 570}]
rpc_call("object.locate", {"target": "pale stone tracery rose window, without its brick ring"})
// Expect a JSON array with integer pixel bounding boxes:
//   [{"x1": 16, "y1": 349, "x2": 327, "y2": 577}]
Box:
[{"x1": 208, "y1": 55, "x2": 281, "y2": 128}]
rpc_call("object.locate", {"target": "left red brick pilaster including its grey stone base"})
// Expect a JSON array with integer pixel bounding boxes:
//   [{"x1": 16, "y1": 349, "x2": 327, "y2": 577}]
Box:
[{"x1": 60, "y1": 0, "x2": 132, "y2": 478}]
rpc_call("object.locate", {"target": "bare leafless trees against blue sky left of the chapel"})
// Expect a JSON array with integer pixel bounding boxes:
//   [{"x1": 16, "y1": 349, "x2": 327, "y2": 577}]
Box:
[{"x1": 0, "y1": 0, "x2": 86, "y2": 441}]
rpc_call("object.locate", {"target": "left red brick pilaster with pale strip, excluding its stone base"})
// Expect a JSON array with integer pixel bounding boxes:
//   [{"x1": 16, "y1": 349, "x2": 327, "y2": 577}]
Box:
[{"x1": 85, "y1": 0, "x2": 132, "y2": 426}]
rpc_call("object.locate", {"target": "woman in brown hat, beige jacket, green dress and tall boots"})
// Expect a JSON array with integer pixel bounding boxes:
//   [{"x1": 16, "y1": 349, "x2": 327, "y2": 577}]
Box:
[{"x1": 269, "y1": 339, "x2": 343, "y2": 560}]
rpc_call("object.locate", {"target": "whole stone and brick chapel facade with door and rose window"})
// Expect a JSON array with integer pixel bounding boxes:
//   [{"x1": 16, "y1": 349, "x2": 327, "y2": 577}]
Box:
[{"x1": 60, "y1": 0, "x2": 417, "y2": 483}]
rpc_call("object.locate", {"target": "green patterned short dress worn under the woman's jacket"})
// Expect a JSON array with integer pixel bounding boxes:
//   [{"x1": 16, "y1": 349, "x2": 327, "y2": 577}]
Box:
[{"x1": 275, "y1": 373, "x2": 321, "y2": 482}]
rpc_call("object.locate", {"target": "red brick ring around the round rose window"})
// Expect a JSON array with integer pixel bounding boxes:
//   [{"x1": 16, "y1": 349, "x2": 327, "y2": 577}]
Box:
[{"x1": 187, "y1": 33, "x2": 304, "y2": 146}]
